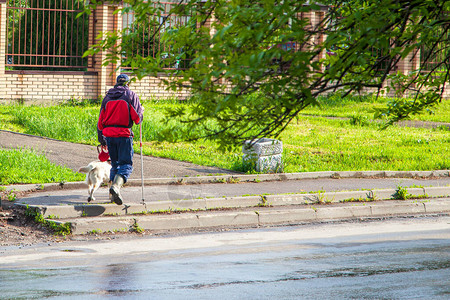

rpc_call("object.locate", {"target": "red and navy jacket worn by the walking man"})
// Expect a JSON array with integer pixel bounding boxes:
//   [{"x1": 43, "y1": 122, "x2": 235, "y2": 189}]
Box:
[{"x1": 97, "y1": 85, "x2": 143, "y2": 145}]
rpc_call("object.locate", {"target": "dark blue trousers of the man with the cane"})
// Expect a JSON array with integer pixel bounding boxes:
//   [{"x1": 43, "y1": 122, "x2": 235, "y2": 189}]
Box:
[{"x1": 105, "y1": 137, "x2": 134, "y2": 182}]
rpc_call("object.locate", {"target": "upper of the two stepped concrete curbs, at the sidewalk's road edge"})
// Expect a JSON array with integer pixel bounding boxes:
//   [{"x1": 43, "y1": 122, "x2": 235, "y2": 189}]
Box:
[{"x1": 15, "y1": 187, "x2": 450, "y2": 219}]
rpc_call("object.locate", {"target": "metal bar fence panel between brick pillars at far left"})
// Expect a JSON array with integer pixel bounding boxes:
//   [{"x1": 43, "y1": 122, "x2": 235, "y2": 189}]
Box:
[{"x1": 6, "y1": 0, "x2": 89, "y2": 70}]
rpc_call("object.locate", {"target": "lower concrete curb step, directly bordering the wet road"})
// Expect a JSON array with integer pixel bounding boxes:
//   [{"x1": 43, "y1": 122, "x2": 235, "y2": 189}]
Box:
[{"x1": 57, "y1": 200, "x2": 450, "y2": 235}]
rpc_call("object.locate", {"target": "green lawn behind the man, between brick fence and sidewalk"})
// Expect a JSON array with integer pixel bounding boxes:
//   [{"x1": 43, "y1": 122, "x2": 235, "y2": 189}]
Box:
[{"x1": 0, "y1": 97, "x2": 450, "y2": 184}]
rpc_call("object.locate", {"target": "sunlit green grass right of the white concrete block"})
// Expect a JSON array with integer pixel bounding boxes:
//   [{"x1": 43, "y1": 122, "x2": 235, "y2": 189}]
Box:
[{"x1": 281, "y1": 118, "x2": 450, "y2": 172}]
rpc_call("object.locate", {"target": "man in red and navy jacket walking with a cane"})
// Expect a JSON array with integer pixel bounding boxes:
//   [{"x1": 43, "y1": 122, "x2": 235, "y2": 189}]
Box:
[{"x1": 97, "y1": 74, "x2": 144, "y2": 205}]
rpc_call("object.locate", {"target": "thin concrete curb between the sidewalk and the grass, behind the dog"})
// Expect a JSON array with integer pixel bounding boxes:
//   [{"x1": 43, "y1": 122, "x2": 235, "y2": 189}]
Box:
[{"x1": 6, "y1": 170, "x2": 450, "y2": 192}]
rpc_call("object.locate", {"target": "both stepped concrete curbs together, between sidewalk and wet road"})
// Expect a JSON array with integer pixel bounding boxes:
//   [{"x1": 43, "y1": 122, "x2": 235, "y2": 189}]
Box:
[{"x1": 16, "y1": 187, "x2": 450, "y2": 234}]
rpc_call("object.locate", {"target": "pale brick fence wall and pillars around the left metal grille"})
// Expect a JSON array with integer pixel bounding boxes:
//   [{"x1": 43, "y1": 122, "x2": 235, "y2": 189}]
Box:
[{"x1": 0, "y1": 0, "x2": 189, "y2": 104}]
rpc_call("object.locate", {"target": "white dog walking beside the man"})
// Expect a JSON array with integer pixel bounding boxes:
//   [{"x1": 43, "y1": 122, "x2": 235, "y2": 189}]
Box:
[{"x1": 78, "y1": 161, "x2": 111, "y2": 202}]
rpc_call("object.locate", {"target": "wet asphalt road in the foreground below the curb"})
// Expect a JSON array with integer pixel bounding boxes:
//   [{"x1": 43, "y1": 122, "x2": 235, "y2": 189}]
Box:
[{"x1": 0, "y1": 216, "x2": 450, "y2": 299}]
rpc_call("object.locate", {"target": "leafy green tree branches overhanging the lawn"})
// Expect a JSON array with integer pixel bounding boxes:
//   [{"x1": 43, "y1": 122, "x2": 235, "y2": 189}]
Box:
[{"x1": 83, "y1": 0, "x2": 450, "y2": 148}]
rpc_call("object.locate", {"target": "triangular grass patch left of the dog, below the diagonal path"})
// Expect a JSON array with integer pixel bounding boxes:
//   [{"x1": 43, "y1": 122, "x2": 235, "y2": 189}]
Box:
[{"x1": 0, "y1": 149, "x2": 85, "y2": 185}]
